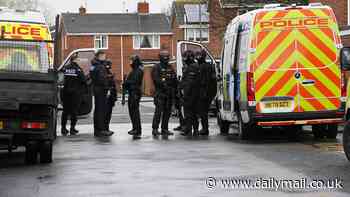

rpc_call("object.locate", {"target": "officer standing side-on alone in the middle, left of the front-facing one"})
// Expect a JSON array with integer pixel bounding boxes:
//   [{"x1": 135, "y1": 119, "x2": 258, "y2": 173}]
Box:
[{"x1": 123, "y1": 55, "x2": 143, "y2": 138}]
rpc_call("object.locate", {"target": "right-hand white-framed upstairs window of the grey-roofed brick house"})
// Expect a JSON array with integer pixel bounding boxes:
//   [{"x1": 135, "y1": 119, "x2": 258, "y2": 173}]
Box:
[{"x1": 134, "y1": 35, "x2": 160, "y2": 49}]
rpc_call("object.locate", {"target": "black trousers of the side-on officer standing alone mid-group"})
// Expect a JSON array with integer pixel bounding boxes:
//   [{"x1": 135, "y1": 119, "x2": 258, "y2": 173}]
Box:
[{"x1": 128, "y1": 92, "x2": 142, "y2": 133}]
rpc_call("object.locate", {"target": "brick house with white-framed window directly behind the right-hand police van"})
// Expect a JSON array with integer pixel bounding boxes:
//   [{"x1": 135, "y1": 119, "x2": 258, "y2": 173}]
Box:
[{"x1": 171, "y1": 0, "x2": 305, "y2": 58}]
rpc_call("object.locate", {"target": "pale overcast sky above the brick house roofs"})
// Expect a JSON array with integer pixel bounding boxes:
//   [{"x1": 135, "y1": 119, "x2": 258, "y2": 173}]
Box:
[{"x1": 41, "y1": 0, "x2": 172, "y2": 13}]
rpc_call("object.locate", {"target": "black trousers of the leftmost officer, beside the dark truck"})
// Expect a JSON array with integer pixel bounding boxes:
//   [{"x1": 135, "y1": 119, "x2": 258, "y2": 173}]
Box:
[{"x1": 61, "y1": 91, "x2": 81, "y2": 128}]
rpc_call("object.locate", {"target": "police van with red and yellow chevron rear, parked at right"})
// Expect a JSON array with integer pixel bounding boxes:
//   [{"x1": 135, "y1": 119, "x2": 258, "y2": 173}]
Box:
[{"x1": 179, "y1": 3, "x2": 346, "y2": 139}]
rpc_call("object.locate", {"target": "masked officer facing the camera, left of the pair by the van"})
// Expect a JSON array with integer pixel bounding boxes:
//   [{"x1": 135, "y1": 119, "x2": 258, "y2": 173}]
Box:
[{"x1": 152, "y1": 51, "x2": 177, "y2": 136}]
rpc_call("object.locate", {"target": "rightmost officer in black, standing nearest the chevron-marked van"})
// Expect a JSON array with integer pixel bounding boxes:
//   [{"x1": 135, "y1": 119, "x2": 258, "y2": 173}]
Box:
[{"x1": 196, "y1": 50, "x2": 217, "y2": 135}]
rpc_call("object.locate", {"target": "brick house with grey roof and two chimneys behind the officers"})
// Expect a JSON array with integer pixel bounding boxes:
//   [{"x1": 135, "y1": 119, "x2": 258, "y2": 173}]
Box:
[{"x1": 58, "y1": 1, "x2": 173, "y2": 95}]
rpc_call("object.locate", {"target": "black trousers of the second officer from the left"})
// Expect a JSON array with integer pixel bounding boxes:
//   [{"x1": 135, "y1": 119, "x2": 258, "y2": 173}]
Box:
[{"x1": 94, "y1": 87, "x2": 108, "y2": 133}]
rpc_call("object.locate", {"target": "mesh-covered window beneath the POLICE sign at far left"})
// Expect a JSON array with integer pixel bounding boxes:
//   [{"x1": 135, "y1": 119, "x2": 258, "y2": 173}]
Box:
[{"x1": 0, "y1": 41, "x2": 52, "y2": 73}]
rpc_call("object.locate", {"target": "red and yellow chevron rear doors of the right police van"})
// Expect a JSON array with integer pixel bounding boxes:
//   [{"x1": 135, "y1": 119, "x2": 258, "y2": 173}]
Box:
[{"x1": 252, "y1": 8, "x2": 341, "y2": 113}]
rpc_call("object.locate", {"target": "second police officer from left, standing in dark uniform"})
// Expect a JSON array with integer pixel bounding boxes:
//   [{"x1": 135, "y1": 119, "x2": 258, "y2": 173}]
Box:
[{"x1": 90, "y1": 51, "x2": 113, "y2": 137}]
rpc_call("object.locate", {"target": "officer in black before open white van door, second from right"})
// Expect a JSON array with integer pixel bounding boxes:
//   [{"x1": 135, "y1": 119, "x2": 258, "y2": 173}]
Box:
[{"x1": 181, "y1": 50, "x2": 200, "y2": 136}]
